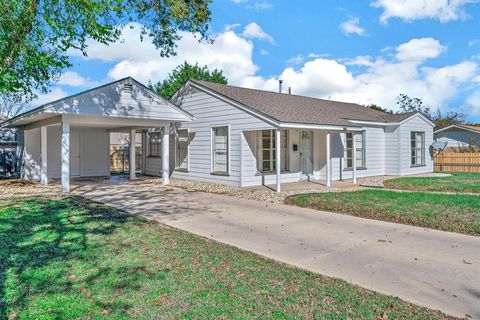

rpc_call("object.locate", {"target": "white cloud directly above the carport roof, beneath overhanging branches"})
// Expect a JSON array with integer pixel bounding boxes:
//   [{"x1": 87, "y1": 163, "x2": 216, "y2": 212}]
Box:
[{"x1": 70, "y1": 25, "x2": 258, "y2": 84}]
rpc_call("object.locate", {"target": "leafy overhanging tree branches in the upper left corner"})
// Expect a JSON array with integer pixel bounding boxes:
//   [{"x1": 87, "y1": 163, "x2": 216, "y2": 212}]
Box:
[{"x1": 0, "y1": 0, "x2": 211, "y2": 101}]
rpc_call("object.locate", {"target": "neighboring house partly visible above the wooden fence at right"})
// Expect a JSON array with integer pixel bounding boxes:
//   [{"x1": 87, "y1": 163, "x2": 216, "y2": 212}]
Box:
[{"x1": 434, "y1": 124, "x2": 480, "y2": 148}]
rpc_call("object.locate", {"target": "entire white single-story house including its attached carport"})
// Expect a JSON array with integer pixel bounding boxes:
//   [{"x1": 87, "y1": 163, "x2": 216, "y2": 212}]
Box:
[{"x1": 3, "y1": 78, "x2": 434, "y2": 191}]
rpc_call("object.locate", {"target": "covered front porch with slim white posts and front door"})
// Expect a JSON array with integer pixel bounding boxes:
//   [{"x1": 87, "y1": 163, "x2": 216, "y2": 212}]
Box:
[{"x1": 240, "y1": 128, "x2": 366, "y2": 192}]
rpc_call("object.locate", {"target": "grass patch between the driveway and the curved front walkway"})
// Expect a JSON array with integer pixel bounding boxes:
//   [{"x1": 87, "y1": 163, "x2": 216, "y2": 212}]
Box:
[{"x1": 286, "y1": 190, "x2": 480, "y2": 236}]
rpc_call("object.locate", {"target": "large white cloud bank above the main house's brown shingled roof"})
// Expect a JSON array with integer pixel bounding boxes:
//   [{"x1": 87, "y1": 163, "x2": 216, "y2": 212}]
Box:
[{"x1": 242, "y1": 39, "x2": 480, "y2": 109}]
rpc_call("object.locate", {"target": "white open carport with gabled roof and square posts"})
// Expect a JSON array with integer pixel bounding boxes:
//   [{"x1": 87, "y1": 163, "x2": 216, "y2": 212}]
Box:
[{"x1": 2, "y1": 77, "x2": 192, "y2": 192}]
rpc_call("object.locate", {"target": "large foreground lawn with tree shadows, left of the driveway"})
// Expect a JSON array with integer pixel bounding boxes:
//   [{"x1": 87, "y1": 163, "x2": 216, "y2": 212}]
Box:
[{"x1": 0, "y1": 197, "x2": 454, "y2": 319}]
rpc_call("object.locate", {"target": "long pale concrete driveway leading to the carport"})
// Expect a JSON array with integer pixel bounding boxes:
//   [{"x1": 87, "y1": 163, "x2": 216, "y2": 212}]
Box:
[{"x1": 74, "y1": 182, "x2": 480, "y2": 319}]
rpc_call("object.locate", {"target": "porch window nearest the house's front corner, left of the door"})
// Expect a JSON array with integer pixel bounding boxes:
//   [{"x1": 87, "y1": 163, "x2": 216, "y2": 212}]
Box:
[{"x1": 256, "y1": 129, "x2": 290, "y2": 173}]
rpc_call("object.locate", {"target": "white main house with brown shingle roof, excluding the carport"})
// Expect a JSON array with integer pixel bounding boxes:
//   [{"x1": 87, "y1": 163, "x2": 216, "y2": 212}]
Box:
[{"x1": 169, "y1": 81, "x2": 434, "y2": 190}]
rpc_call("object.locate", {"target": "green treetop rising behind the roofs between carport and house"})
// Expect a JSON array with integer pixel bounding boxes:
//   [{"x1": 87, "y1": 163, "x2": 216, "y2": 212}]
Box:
[{"x1": 149, "y1": 61, "x2": 228, "y2": 99}]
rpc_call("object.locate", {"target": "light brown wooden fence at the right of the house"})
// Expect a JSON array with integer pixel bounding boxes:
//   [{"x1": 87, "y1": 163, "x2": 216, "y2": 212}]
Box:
[{"x1": 434, "y1": 151, "x2": 480, "y2": 172}]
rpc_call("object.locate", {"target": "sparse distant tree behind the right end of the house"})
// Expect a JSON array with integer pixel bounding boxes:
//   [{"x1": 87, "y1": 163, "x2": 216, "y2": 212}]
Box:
[{"x1": 397, "y1": 94, "x2": 468, "y2": 128}]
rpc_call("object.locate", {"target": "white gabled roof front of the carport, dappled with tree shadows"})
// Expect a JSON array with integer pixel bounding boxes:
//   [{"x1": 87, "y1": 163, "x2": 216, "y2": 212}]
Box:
[{"x1": 2, "y1": 77, "x2": 193, "y2": 127}]
